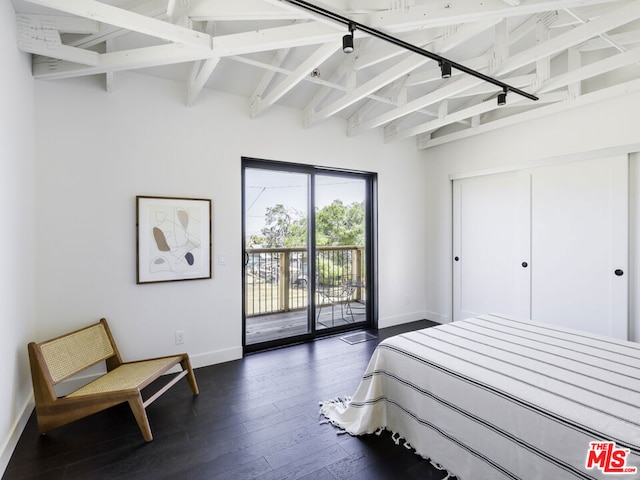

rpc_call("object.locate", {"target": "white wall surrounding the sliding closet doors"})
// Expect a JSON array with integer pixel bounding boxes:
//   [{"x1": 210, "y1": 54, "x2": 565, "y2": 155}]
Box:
[{"x1": 423, "y1": 92, "x2": 640, "y2": 341}]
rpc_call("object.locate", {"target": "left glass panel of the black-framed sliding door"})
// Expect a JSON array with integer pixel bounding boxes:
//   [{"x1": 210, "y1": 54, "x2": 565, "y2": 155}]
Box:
[{"x1": 244, "y1": 168, "x2": 311, "y2": 345}]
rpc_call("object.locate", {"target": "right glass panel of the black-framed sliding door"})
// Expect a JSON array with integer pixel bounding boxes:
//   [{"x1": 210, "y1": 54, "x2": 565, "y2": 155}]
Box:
[{"x1": 314, "y1": 174, "x2": 368, "y2": 330}]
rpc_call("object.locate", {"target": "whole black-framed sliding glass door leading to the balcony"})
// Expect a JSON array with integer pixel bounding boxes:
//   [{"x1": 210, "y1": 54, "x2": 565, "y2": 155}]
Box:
[{"x1": 243, "y1": 158, "x2": 375, "y2": 351}]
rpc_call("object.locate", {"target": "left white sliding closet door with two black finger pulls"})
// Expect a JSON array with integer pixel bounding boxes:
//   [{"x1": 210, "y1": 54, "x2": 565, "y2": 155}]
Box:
[{"x1": 452, "y1": 173, "x2": 531, "y2": 320}]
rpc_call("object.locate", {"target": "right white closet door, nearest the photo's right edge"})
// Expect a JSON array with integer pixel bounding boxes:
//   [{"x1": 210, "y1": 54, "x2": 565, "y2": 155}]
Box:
[{"x1": 531, "y1": 156, "x2": 628, "y2": 339}]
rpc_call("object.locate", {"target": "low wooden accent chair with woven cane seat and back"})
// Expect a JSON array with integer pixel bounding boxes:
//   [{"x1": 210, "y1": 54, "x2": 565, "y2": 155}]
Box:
[{"x1": 28, "y1": 318, "x2": 199, "y2": 442}]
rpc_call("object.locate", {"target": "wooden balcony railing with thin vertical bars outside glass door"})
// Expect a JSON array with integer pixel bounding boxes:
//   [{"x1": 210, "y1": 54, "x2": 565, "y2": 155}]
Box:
[{"x1": 244, "y1": 246, "x2": 365, "y2": 317}]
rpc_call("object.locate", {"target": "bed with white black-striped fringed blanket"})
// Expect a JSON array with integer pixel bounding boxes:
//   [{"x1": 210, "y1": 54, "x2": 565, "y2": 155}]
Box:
[{"x1": 321, "y1": 315, "x2": 640, "y2": 480}]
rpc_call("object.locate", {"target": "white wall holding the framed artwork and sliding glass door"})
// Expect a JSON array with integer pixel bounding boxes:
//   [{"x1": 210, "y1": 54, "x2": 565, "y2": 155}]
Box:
[{"x1": 35, "y1": 73, "x2": 427, "y2": 366}]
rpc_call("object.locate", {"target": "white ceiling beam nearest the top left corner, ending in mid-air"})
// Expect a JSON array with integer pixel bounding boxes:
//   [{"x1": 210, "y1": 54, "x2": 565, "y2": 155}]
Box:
[{"x1": 28, "y1": 0, "x2": 211, "y2": 50}]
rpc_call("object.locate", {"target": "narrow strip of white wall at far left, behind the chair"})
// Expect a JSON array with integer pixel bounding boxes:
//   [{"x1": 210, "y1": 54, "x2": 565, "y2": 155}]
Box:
[{"x1": 0, "y1": 2, "x2": 36, "y2": 472}]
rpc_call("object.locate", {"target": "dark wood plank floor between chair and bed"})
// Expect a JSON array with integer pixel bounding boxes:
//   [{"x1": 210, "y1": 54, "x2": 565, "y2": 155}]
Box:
[{"x1": 2, "y1": 321, "x2": 456, "y2": 480}]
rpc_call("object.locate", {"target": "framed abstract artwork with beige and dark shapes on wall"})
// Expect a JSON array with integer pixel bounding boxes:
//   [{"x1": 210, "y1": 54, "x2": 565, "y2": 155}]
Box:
[{"x1": 136, "y1": 196, "x2": 211, "y2": 284}]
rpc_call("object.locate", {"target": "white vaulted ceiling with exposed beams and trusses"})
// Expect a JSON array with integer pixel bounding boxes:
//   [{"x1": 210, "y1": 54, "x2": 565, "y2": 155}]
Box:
[{"x1": 13, "y1": 0, "x2": 640, "y2": 149}]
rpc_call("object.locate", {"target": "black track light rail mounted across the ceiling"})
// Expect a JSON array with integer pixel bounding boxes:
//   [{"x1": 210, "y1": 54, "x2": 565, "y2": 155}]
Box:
[{"x1": 281, "y1": 0, "x2": 539, "y2": 100}]
